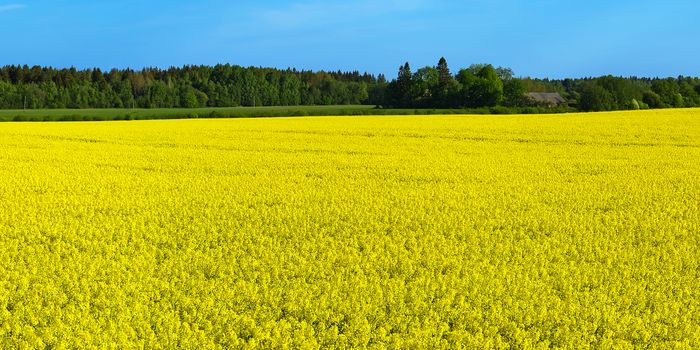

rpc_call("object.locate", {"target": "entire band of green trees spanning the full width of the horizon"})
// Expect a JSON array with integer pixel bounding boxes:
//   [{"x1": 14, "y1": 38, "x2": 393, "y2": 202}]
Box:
[{"x1": 0, "y1": 58, "x2": 700, "y2": 111}]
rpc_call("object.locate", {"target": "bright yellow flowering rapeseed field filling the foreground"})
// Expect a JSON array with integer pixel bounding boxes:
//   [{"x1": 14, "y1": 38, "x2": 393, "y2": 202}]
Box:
[{"x1": 0, "y1": 110, "x2": 700, "y2": 349}]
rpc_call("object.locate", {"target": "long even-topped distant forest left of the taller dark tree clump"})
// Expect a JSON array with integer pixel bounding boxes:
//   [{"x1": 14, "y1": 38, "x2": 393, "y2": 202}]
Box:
[{"x1": 0, "y1": 65, "x2": 377, "y2": 109}]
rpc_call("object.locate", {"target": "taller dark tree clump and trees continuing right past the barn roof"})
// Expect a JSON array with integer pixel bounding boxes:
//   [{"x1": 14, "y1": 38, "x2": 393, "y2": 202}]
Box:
[{"x1": 380, "y1": 58, "x2": 700, "y2": 111}]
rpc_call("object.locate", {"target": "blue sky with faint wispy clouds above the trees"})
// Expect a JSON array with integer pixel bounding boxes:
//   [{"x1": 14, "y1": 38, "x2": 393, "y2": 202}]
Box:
[{"x1": 0, "y1": 0, "x2": 700, "y2": 78}]
